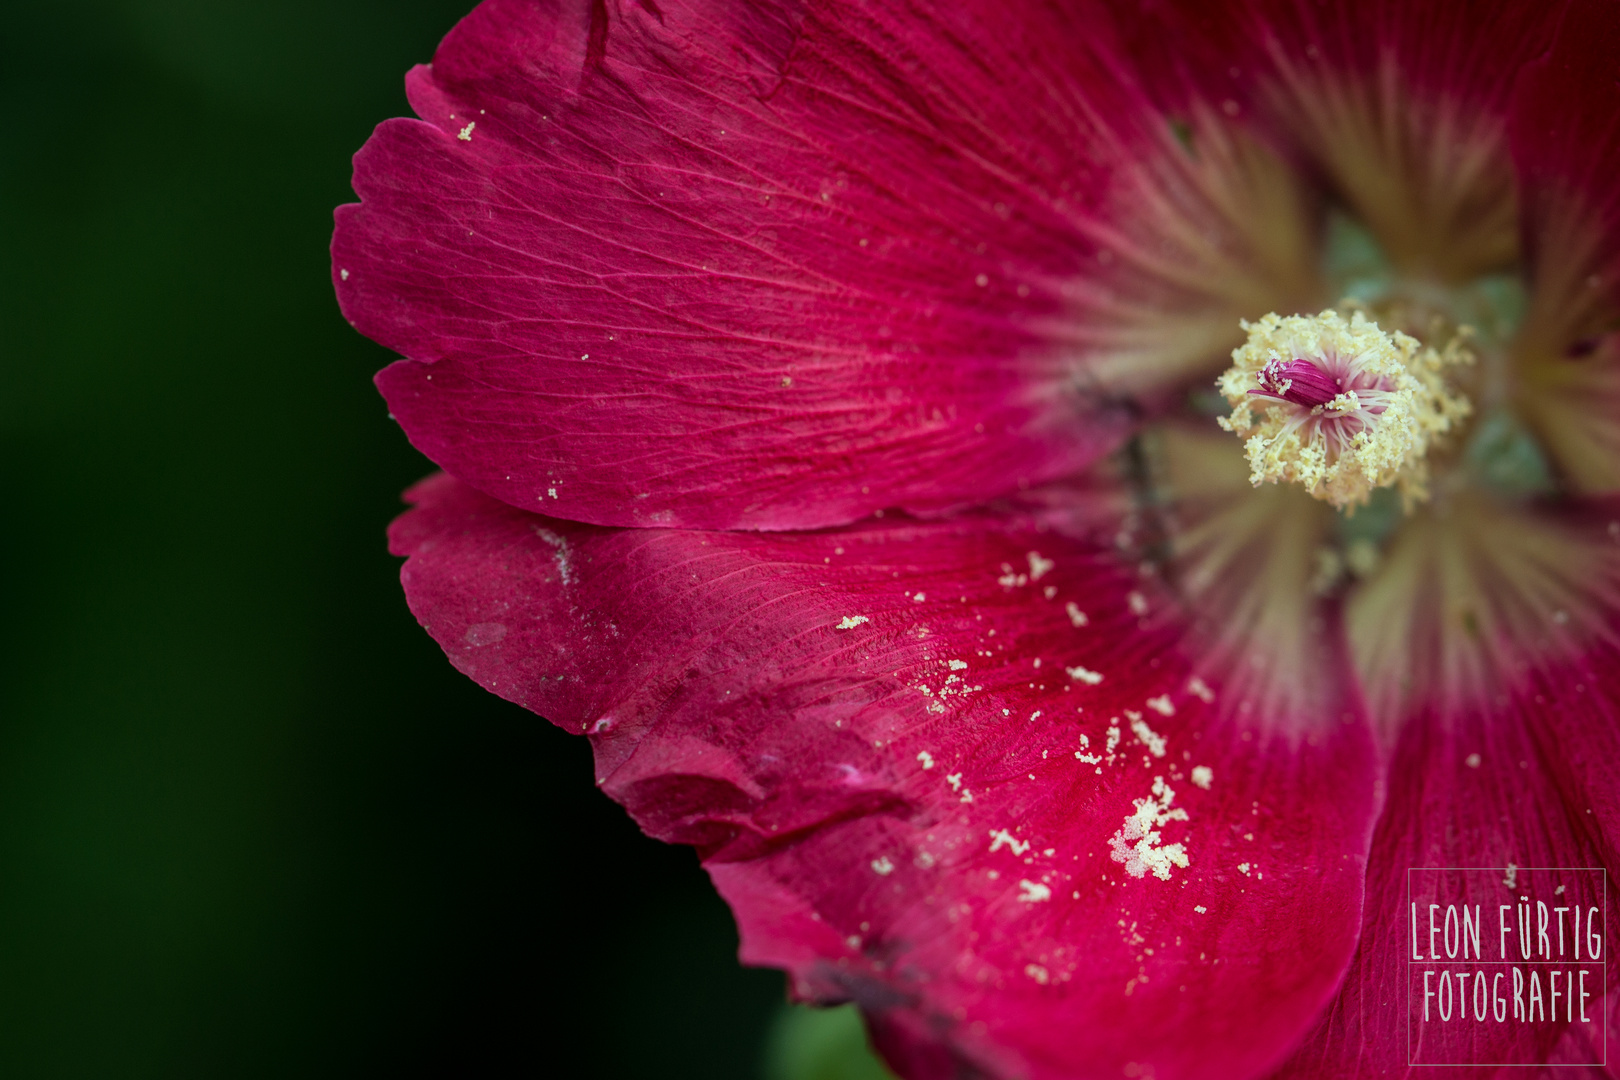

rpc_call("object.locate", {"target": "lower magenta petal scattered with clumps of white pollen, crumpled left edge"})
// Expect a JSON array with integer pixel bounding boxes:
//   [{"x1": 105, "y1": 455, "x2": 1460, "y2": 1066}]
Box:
[{"x1": 392, "y1": 476, "x2": 1374, "y2": 1080}]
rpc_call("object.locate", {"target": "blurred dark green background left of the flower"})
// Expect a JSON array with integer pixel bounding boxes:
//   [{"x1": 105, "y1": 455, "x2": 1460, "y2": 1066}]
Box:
[{"x1": 0, "y1": 0, "x2": 797, "y2": 1080}]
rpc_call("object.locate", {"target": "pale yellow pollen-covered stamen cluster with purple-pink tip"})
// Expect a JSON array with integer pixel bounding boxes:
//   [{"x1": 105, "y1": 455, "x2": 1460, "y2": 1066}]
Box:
[{"x1": 1215, "y1": 309, "x2": 1474, "y2": 510}]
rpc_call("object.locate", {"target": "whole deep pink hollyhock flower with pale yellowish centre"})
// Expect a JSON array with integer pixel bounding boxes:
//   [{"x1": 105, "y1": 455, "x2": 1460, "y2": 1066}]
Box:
[{"x1": 332, "y1": 0, "x2": 1620, "y2": 1078}]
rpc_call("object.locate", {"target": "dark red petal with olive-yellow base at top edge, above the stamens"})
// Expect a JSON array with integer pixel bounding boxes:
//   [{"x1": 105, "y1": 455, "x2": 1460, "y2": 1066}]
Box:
[{"x1": 1118, "y1": 0, "x2": 1560, "y2": 283}]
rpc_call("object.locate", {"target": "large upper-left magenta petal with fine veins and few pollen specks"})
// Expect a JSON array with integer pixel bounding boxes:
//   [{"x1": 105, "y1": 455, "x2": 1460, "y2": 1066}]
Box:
[{"x1": 332, "y1": 0, "x2": 1158, "y2": 529}]
